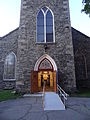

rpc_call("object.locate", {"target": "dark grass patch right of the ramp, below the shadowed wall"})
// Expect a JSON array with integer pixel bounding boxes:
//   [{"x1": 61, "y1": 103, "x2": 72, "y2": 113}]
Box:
[{"x1": 71, "y1": 90, "x2": 90, "y2": 98}]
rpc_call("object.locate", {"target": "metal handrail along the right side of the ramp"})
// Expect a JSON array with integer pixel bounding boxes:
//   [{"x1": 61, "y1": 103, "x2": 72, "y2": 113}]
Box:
[{"x1": 57, "y1": 84, "x2": 69, "y2": 105}]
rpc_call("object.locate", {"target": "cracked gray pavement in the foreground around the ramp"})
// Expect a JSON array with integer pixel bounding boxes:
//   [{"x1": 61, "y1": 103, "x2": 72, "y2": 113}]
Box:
[{"x1": 0, "y1": 97, "x2": 90, "y2": 120}]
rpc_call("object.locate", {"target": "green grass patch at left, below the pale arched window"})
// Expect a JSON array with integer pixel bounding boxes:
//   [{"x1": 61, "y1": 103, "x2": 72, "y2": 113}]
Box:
[{"x1": 0, "y1": 90, "x2": 21, "y2": 102}]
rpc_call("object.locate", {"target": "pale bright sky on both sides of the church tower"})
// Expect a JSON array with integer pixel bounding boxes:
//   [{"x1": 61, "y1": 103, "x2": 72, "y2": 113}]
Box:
[{"x1": 0, "y1": 0, "x2": 90, "y2": 37}]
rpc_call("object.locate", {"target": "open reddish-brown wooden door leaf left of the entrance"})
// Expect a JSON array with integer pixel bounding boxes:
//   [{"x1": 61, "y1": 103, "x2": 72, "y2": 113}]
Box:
[{"x1": 31, "y1": 71, "x2": 39, "y2": 93}]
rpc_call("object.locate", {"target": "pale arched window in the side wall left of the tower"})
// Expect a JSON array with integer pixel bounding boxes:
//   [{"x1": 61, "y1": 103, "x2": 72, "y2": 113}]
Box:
[{"x1": 4, "y1": 53, "x2": 16, "y2": 80}]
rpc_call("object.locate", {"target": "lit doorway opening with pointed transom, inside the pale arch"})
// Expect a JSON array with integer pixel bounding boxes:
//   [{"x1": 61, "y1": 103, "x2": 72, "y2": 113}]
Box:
[{"x1": 38, "y1": 58, "x2": 54, "y2": 91}]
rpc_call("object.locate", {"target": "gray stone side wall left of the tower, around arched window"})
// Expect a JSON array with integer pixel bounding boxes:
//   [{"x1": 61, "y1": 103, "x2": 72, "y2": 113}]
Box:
[{"x1": 0, "y1": 28, "x2": 18, "y2": 89}]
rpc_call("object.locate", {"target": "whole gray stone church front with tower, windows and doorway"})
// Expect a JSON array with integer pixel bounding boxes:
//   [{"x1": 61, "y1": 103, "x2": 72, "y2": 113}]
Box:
[{"x1": 0, "y1": 0, "x2": 90, "y2": 93}]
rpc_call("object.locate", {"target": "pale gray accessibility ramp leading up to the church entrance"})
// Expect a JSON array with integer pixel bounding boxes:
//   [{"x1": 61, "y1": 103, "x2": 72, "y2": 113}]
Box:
[{"x1": 44, "y1": 92, "x2": 65, "y2": 110}]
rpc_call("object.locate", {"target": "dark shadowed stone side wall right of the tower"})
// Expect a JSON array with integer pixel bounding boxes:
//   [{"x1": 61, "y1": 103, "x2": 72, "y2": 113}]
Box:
[{"x1": 72, "y1": 28, "x2": 90, "y2": 89}]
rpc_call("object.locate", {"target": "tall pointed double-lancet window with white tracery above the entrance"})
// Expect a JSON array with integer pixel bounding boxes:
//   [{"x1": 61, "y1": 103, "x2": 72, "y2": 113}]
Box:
[{"x1": 37, "y1": 7, "x2": 55, "y2": 43}]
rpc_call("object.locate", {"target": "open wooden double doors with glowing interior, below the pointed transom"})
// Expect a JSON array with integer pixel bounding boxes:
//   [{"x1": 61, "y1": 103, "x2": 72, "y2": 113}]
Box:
[{"x1": 31, "y1": 70, "x2": 57, "y2": 93}]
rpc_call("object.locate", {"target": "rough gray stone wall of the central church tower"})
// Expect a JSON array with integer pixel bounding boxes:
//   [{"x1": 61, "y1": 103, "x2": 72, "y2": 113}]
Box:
[{"x1": 16, "y1": 0, "x2": 76, "y2": 91}]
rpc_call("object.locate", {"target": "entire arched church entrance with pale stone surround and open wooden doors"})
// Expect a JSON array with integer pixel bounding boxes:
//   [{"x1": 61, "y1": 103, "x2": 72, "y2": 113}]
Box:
[{"x1": 31, "y1": 54, "x2": 57, "y2": 93}]
